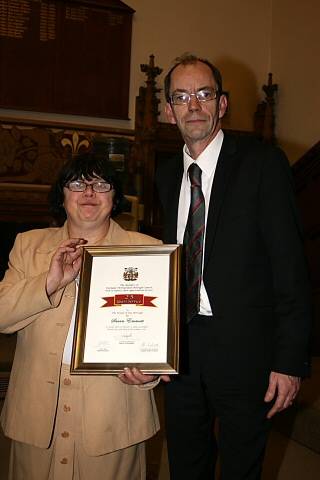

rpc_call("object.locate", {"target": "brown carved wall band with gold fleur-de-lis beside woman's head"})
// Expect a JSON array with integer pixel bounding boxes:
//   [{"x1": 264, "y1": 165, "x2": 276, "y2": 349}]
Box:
[{"x1": 0, "y1": 123, "x2": 133, "y2": 225}]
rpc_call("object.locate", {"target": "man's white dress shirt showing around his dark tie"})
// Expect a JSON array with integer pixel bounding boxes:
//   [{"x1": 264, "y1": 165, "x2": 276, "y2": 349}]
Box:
[{"x1": 177, "y1": 130, "x2": 224, "y2": 315}]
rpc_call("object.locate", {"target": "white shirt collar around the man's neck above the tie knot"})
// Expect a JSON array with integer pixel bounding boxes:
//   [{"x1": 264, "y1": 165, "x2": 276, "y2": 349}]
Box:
[{"x1": 183, "y1": 130, "x2": 224, "y2": 177}]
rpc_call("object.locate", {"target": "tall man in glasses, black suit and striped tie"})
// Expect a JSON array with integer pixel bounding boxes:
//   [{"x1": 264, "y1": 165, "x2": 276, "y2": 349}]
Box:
[{"x1": 157, "y1": 55, "x2": 310, "y2": 480}]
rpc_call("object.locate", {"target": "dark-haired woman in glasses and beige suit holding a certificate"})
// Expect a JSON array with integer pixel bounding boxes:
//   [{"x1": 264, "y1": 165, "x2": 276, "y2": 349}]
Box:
[{"x1": 0, "y1": 154, "x2": 164, "y2": 480}]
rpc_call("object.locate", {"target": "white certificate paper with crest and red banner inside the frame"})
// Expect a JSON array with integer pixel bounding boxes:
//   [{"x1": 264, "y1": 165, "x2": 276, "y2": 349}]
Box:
[{"x1": 83, "y1": 255, "x2": 169, "y2": 365}]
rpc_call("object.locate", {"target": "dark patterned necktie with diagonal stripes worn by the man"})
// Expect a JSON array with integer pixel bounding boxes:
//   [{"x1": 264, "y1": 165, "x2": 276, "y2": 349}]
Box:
[{"x1": 183, "y1": 163, "x2": 205, "y2": 322}]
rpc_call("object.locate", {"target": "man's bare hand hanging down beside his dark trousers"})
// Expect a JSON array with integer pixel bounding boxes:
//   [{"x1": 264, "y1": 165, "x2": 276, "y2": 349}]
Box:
[{"x1": 264, "y1": 372, "x2": 301, "y2": 418}]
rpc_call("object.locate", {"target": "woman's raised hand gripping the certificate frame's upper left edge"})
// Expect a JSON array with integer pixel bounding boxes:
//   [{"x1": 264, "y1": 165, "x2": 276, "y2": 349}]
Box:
[{"x1": 46, "y1": 238, "x2": 87, "y2": 297}]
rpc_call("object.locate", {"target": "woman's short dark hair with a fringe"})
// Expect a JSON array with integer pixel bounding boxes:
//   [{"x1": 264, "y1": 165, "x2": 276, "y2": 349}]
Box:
[{"x1": 49, "y1": 152, "x2": 124, "y2": 220}]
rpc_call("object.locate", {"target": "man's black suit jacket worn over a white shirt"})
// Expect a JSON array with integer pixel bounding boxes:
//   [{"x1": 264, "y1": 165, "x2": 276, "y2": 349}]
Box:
[{"x1": 156, "y1": 134, "x2": 311, "y2": 388}]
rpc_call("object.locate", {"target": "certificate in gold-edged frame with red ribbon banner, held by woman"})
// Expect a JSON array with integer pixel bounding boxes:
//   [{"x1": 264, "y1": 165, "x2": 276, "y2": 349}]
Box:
[{"x1": 71, "y1": 245, "x2": 181, "y2": 375}]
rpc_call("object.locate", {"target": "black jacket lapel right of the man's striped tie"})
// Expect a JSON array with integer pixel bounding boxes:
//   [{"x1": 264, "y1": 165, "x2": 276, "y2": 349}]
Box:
[{"x1": 204, "y1": 134, "x2": 236, "y2": 265}]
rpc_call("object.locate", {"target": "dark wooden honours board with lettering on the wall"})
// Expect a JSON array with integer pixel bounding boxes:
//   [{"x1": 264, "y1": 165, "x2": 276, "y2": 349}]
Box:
[{"x1": 0, "y1": 0, "x2": 134, "y2": 119}]
